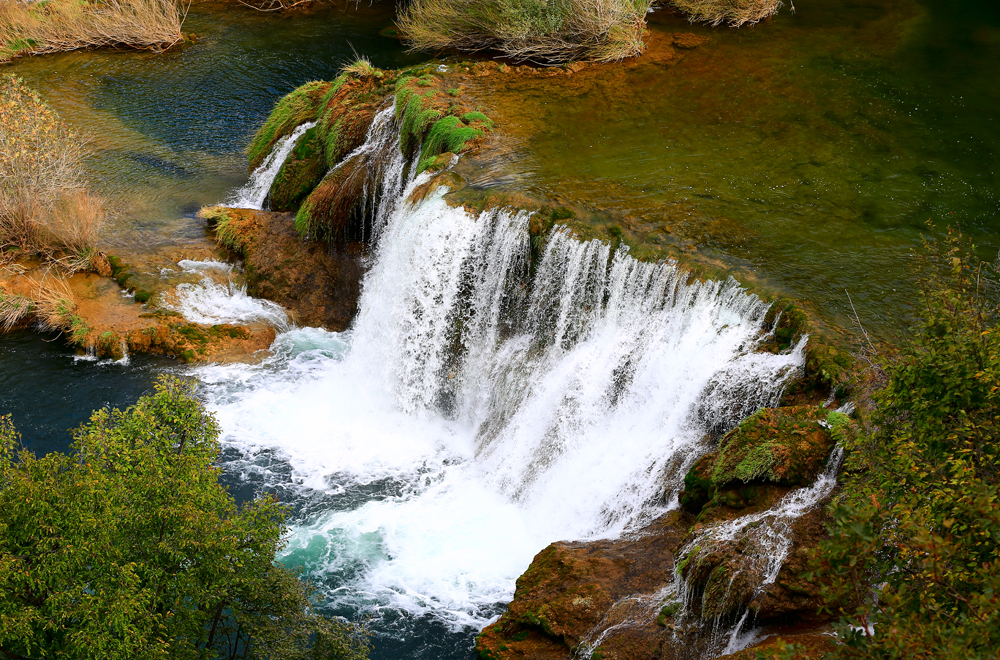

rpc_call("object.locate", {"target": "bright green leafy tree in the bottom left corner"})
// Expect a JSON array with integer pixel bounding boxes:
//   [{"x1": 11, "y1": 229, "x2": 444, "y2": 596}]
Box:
[{"x1": 0, "y1": 377, "x2": 368, "y2": 660}]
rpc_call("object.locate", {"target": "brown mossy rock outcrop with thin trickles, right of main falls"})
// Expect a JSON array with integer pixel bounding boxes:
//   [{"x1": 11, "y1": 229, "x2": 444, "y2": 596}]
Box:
[{"x1": 477, "y1": 406, "x2": 848, "y2": 660}]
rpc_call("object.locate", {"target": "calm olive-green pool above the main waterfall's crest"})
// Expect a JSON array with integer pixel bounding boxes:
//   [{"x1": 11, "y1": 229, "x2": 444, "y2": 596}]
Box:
[{"x1": 488, "y1": 0, "x2": 1000, "y2": 332}]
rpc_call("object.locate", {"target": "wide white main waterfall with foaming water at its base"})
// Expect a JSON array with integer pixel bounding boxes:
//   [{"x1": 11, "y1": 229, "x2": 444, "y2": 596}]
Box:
[{"x1": 195, "y1": 111, "x2": 803, "y2": 658}]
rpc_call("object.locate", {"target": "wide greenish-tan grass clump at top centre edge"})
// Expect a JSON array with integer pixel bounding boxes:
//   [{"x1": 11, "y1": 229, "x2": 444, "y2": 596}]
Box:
[{"x1": 398, "y1": 0, "x2": 651, "y2": 63}]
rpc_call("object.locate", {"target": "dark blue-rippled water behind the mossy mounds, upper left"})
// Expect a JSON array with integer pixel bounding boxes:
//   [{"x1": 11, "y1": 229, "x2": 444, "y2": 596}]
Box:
[{"x1": 8, "y1": 3, "x2": 425, "y2": 242}]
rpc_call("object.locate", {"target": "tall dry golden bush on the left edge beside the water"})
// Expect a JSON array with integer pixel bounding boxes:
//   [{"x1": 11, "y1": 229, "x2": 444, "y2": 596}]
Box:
[{"x1": 0, "y1": 76, "x2": 105, "y2": 271}]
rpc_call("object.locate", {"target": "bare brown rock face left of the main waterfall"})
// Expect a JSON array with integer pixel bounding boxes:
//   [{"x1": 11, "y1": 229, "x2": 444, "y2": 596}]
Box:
[{"x1": 207, "y1": 209, "x2": 364, "y2": 332}]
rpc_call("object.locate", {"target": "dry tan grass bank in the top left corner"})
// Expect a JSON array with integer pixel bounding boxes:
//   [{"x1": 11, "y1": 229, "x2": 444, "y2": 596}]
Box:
[{"x1": 0, "y1": 0, "x2": 186, "y2": 60}]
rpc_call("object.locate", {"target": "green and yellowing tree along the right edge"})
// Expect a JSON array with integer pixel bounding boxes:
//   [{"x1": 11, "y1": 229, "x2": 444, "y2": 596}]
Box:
[{"x1": 815, "y1": 228, "x2": 1000, "y2": 660}]
